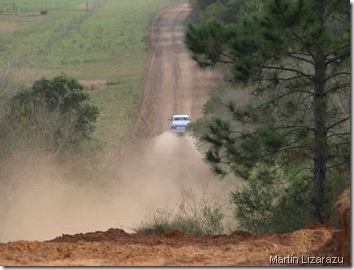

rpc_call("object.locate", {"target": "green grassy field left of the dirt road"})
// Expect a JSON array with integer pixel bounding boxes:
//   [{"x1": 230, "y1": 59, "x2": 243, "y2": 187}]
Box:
[{"x1": 0, "y1": 0, "x2": 178, "y2": 147}]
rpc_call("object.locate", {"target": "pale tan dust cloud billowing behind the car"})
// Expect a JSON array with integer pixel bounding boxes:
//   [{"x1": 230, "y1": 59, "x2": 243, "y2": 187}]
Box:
[{"x1": 0, "y1": 132, "x2": 235, "y2": 242}]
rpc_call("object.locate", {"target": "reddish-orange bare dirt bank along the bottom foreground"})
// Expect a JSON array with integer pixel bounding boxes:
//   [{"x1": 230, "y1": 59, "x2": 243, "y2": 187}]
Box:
[{"x1": 0, "y1": 189, "x2": 350, "y2": 266}]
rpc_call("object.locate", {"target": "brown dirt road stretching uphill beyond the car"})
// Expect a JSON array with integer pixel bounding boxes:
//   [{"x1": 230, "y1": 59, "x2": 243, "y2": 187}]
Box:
[{"x1": 121, "y1": 4, "x2": 222, "y2": 143}]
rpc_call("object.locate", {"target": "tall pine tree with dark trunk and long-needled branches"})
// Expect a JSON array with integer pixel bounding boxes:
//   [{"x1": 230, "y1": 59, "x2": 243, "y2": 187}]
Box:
[{"x1": 185, "y1": 0, "x2": 350, "y2": 222}]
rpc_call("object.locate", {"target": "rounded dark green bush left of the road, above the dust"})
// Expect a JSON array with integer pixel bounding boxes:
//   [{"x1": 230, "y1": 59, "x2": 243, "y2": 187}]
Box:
[{"x1": 9, "y1": 75, "x2": 98, "y2": 155}]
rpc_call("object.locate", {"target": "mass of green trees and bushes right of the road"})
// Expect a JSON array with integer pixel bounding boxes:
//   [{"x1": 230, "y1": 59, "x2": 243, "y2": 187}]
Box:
[{"x1": 185, "y1": 0, "x2": 350, "y2": 233}]
